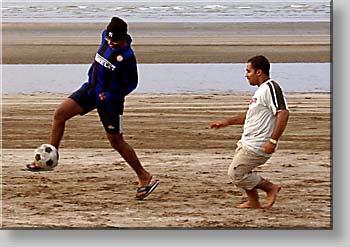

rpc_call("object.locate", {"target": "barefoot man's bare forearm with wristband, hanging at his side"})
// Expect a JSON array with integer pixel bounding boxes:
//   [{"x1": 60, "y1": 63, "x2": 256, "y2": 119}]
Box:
[{"x1": 264, "y1": 110, "x2": 289, "y2": 154}]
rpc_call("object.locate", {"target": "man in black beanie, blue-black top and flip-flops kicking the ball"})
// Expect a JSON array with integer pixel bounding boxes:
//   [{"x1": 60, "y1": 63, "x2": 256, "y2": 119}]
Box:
[{"x1": 27, "y1": 17, "x2": 159, "y2": 199}]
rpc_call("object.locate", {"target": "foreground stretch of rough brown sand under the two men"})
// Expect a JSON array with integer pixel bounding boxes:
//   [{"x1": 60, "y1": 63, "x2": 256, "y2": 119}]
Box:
[{"x1": 2, "y1": 93, "x2": 332, "y2": 229}]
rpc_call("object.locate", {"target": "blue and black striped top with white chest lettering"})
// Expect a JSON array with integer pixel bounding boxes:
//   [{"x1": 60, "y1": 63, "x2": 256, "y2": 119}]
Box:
[{"x1": 83, "y1": 30, "x2": 138, "y2": 110}]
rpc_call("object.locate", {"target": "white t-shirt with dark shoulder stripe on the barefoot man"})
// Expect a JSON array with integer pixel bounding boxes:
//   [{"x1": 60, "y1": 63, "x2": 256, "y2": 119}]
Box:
[{"x1": 241, "y1": 79, "x2": 288, "y2": 156}]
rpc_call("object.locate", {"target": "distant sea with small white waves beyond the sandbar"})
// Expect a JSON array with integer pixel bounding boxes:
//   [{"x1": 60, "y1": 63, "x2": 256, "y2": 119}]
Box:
[{"x1": 1, "y1": 0, "x2": 331, "y2": 22}]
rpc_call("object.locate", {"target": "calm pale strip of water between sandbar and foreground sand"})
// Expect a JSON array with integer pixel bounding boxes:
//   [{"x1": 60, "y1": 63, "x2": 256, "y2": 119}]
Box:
[{"x1": 2, "y1": 63, "x2": 332, "y2": 94}]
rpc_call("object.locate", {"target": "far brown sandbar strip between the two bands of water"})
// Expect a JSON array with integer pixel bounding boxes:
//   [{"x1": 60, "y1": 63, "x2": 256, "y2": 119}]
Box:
[{"x1": 2, "y1": 22, "x2": 331, "y2": 64}]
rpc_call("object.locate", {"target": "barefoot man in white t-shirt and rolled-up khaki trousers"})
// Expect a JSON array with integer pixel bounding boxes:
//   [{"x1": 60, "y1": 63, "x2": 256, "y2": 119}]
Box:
[{"x1": 210, "y1": 56, "x2": 289, "y2": 208}]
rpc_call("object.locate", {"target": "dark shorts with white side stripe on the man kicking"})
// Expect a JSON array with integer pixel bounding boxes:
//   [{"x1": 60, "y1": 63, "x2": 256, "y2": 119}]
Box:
[{"x1": 68, "y1": 87, "x2": 124, "y2": 134}]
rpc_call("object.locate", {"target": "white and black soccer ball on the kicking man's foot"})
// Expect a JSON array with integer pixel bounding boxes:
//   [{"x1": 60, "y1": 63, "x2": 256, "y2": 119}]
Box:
[{"x1": 34, "y1": 144, "x2": 58, "y2": 170}]
